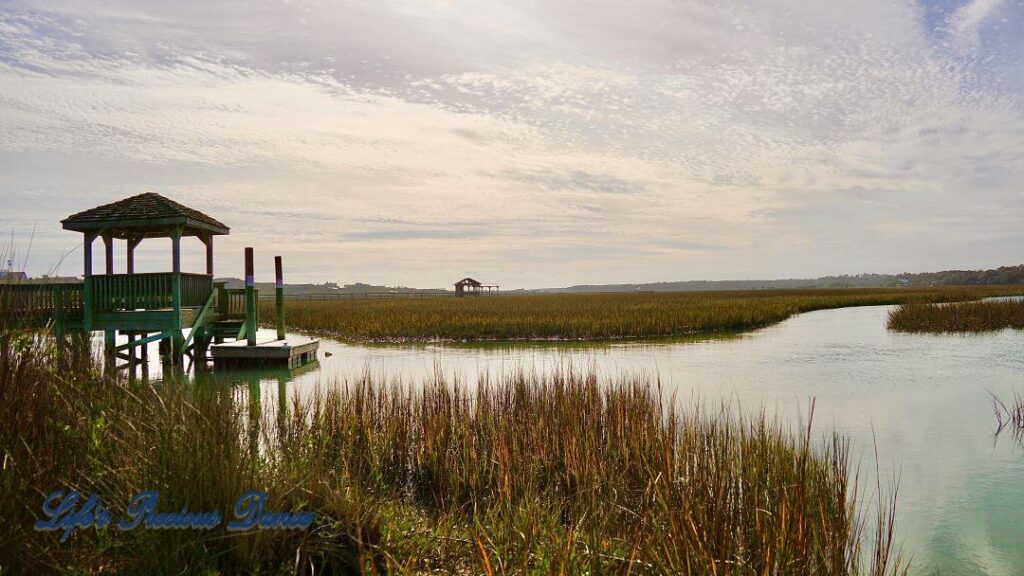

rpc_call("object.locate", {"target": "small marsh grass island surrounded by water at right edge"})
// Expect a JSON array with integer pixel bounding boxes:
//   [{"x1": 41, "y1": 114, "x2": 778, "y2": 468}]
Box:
[{"x1": 889, "y1": 300, "x2": 1024, "y2": 333}]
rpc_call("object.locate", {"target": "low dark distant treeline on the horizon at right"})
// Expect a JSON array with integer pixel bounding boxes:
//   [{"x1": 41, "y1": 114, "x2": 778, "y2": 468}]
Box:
[{"x1": 541, "y1": 264, "x2": 1024, "y2": 292}]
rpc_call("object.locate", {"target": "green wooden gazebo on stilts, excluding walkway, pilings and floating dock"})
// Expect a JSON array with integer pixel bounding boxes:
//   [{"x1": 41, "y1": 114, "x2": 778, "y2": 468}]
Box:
[{"x1": 61, "y1": 193, "x2": 240, "y2": 360}]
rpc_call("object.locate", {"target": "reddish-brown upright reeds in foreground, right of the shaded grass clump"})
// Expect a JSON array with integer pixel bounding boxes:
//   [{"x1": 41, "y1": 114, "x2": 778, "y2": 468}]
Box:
[{"x1": 284, "y1": 371, "x2": 902, "y2": 574}]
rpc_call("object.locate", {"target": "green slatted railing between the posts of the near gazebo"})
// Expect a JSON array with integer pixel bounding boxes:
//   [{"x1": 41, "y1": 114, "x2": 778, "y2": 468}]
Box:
[{"x1": 88, "y1": 272, "x2": 213, "y2": 313}]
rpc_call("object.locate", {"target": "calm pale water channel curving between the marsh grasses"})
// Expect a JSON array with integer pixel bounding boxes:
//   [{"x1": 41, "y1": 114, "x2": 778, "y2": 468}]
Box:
[{"x1": 176, "y1": 306, "x2": 1024, "y2": 575}]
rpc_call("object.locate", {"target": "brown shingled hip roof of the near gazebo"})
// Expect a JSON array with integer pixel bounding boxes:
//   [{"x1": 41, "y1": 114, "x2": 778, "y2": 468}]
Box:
[{"x1": 60, "y1": 192, "x2": 230, "y2": 239}]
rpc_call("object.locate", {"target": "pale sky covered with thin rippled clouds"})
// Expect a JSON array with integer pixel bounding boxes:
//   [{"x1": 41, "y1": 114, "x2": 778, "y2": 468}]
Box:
[{"x1": 0, "y1": 0, "x2": 1024, "y2": 288}]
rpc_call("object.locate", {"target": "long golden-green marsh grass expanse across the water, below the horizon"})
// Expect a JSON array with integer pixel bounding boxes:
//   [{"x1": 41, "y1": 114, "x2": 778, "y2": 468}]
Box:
[{"x1": 272, "y1": 287, "x2": 1024, "y2": 342}]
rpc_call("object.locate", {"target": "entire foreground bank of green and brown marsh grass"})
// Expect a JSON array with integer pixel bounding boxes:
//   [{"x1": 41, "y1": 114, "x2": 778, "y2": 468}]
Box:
[{"x1": 6, "y1": 289, "x2": 902, "y2": 575}]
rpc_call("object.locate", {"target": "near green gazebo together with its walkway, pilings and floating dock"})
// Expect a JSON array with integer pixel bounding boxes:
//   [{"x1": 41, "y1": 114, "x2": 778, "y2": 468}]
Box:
[{"x1": 0, "y1": 193, "x2": 319, "y2": 374}]
